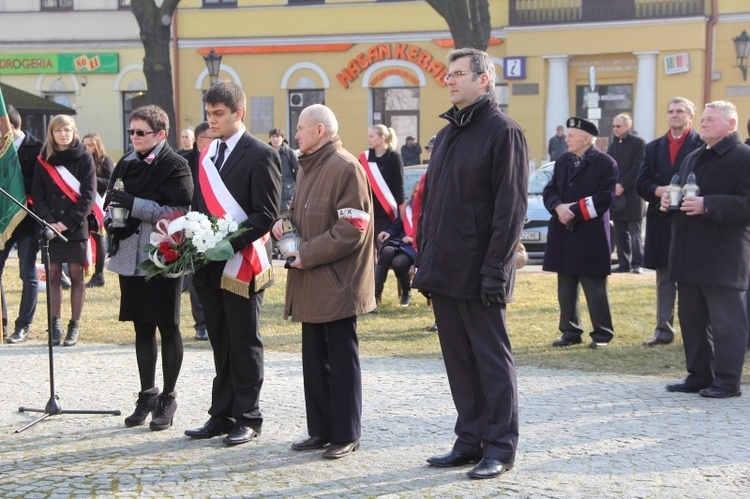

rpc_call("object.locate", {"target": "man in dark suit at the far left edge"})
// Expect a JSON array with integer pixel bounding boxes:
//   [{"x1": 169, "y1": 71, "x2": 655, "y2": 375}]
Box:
[{"x1": 0, "y1": 106, "x2": 42, "y2": 343}]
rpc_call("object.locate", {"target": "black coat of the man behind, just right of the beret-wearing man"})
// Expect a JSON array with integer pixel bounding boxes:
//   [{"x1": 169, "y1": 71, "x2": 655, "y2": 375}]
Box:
[{"x1": 607, "y1": 133, "x2": 646, "y2": 221}]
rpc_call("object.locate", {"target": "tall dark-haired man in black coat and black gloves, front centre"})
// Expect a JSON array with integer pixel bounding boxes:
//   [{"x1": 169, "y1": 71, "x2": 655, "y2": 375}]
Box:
[{"x1": 412, "y1": 48, "x2": 529, "y2": 478}]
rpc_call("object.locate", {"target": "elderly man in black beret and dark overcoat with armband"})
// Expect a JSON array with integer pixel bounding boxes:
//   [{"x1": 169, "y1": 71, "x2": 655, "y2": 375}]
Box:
[{"x1": 542, "y1": 117, "x2": 617, "y2": 348}]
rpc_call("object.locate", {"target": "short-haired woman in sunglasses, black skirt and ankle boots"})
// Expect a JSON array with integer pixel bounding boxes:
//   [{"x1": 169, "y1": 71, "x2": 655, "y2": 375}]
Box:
[{"x1": 104, "y1": 106, "x2": 193, "y2": 431}]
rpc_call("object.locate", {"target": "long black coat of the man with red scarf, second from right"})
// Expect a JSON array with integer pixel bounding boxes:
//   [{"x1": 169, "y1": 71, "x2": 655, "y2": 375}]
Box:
[{"x1": 636, "y1": 129, "x2": 703, "y2": 269}]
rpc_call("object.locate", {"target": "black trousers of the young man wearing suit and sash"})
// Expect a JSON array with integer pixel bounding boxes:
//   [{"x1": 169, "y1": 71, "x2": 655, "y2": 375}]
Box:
[{"x1": 196, "y1": 286, "x2": 263, "y2": 433}]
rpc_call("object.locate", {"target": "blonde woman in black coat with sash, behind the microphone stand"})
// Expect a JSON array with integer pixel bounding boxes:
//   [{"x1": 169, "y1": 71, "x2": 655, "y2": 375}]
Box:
[{"x1": 31, "y1": 114, "x2": 96, "y2": 347}]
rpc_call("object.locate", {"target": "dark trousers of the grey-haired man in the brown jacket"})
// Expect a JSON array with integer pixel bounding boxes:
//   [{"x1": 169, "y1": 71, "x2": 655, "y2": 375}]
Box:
[{"x1": 302, "y1": 316, "x2": 362, "y2": 444}]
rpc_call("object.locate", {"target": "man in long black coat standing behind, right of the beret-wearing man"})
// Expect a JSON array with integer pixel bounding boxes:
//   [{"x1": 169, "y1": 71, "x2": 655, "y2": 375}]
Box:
[{"x1": 607, "y1": 114, "x2": 646, "y2": 274}]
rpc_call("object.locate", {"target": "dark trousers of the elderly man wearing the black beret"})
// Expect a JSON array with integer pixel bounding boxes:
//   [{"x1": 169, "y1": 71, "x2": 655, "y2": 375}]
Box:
[{"x1": 557, "y1": 274, "x2": 615, "y2": 342}]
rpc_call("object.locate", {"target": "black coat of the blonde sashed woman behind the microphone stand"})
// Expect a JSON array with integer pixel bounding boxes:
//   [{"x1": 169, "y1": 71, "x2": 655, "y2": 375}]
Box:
[{"x1": 31, "y1": 139, "x2": 96, "y2": 241}]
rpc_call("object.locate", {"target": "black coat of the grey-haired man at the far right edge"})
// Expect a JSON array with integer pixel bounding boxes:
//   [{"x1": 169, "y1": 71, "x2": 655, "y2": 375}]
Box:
[{"x1": 669, "y1": 132, "x2": 750, "y2": 290}]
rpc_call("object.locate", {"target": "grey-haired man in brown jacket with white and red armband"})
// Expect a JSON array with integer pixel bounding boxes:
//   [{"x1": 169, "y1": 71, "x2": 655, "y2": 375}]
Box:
[{"x1": 273, "y1": 104, "x2": 375, "y2": 459}]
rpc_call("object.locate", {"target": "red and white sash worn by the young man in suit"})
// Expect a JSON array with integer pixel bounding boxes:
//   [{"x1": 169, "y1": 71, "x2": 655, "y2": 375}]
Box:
[{"x1": 198, "y1": 140, "x2": 273, "y2": 298}]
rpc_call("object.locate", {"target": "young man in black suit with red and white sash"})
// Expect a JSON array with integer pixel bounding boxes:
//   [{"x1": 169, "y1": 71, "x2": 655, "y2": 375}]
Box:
[{"x1": 185, "y1": 82, "x2": 281, "y2": 445}]
